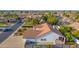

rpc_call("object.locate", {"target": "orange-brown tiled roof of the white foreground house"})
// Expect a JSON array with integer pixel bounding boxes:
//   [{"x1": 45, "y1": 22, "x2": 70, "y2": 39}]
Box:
[{"x1": 24, "y1": 23, "x2": 51, "y2": 38}]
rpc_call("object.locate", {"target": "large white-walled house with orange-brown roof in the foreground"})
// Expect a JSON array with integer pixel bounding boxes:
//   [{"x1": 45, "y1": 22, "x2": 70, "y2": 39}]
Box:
[{"x1": 24, "y1": 23, "x2": 65, "y2": 45}]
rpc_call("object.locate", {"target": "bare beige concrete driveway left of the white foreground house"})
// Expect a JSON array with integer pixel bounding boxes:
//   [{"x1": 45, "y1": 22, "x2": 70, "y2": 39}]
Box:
[{"x1": 0, "y1": 36, "x2": 24, "y2": 48}]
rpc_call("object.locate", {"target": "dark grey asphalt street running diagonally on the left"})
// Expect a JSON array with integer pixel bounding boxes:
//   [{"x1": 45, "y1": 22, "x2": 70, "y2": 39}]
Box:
[{"x1": 0, "y1": 23, "x2": 23, "y2": 44}]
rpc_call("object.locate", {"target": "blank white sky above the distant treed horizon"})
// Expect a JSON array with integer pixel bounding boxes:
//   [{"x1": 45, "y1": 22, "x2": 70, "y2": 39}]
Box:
[{"x1": 0, "y1": 0, "x2": 79, "y2": 10}]
